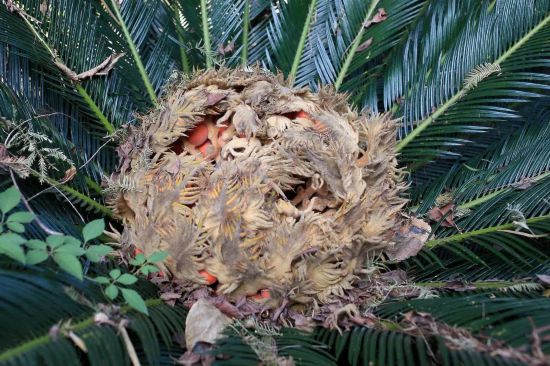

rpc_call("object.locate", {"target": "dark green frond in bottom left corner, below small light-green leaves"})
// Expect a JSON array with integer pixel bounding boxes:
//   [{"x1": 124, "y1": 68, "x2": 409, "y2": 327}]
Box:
[{"x1": 0, "y1": 263, "x2": 185, "y2": 365}]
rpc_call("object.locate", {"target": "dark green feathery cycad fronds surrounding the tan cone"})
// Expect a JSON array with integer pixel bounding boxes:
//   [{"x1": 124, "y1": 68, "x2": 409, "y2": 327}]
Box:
[{"x1": 0, "y1": 0, "x2": 550, "y2": 365}]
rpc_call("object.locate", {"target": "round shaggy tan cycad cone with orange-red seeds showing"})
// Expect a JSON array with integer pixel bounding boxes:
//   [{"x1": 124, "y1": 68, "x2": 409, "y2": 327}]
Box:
[{"x1": 112, "y1": 69, "x2": 426, "y2": 318}]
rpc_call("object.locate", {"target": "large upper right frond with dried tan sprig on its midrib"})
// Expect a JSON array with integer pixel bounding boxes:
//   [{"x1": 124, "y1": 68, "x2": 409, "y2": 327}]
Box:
[{"x1": 392, "y1": 1, "x2": 550, "y2": 163}]
